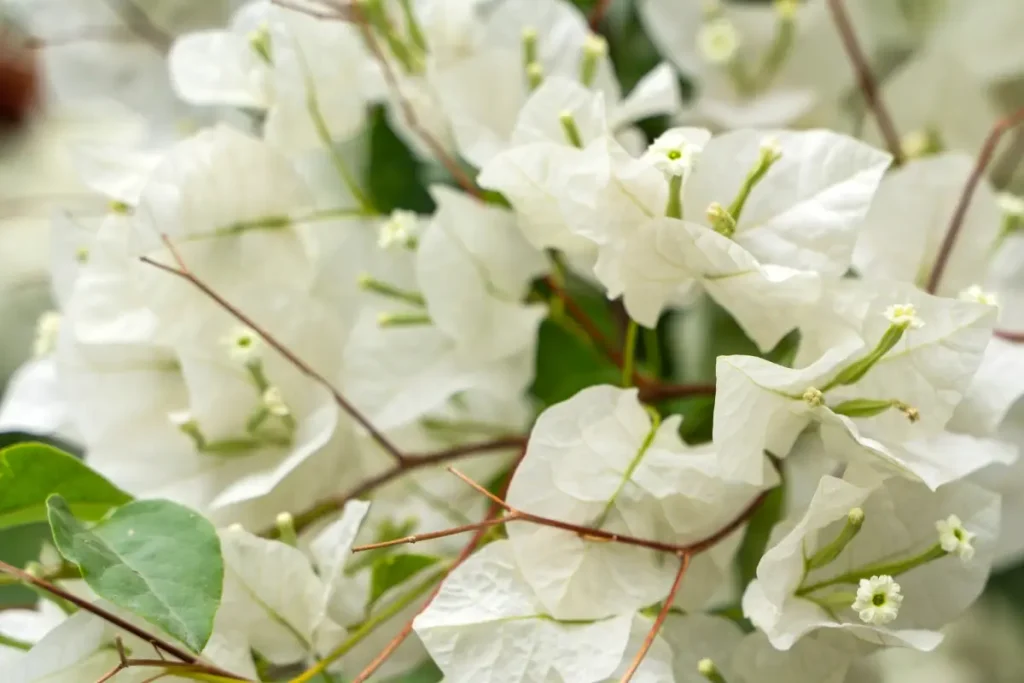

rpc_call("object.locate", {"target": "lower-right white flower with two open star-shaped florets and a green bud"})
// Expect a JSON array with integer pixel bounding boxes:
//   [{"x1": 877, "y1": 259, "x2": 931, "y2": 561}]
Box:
[{"x1": 743, "y1": 467, "x2": 999, "y2": 650}]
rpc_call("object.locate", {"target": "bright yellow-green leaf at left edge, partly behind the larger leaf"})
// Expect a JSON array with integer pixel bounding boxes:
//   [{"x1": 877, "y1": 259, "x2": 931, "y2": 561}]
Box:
[{"x1": 0, "y1": 443, "x2": 132, "y2": 528}]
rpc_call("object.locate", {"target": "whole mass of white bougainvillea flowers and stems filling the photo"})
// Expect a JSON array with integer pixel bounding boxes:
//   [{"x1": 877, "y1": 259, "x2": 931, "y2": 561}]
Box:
[{"x1": 0, "y1": 0, "x2": 1024, "y2": 683}]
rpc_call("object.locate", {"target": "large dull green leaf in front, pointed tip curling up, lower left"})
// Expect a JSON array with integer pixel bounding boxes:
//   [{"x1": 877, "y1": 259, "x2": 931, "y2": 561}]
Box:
[{"x1": 47, "y1": 496, "x2": 224, "y2": 652}]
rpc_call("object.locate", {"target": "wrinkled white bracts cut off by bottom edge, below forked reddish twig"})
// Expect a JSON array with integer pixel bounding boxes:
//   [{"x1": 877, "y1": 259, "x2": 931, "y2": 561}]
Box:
[{"x1": 413, "y1": 541, "x2": 671, "y2": 683}]
